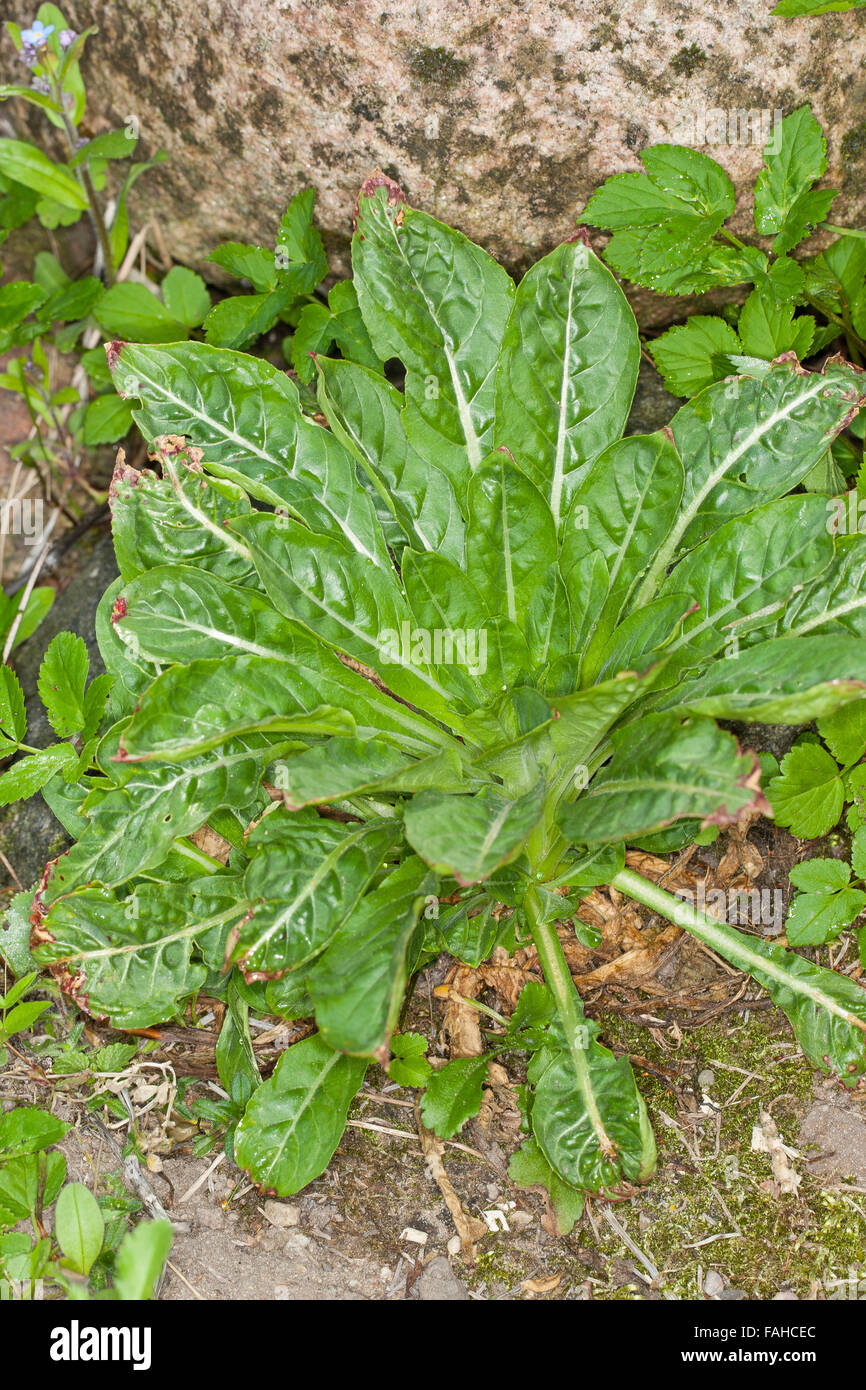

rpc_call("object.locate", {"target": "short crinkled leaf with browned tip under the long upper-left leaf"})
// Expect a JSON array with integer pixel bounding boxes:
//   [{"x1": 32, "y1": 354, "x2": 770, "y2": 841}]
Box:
[{"x1": 108, "y1": 449, "x2": 256, "y2": 584}]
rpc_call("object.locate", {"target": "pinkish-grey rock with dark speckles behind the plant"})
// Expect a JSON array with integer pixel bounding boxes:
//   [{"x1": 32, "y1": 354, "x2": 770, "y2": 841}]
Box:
[{"x1": 0, "y1": 0, "x2": 866, "y2": 306}]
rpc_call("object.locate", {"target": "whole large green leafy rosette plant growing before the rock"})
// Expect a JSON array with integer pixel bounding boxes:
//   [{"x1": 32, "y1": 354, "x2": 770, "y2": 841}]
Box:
[{"x1": 11, "y1": 174, "x2": 866, "y2": 1209}]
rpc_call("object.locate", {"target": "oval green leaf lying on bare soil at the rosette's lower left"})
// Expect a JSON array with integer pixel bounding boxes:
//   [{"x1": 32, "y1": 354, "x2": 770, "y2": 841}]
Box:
[{"x1": 235, "y1": 1034, "x2": 367, "y2": 1197}]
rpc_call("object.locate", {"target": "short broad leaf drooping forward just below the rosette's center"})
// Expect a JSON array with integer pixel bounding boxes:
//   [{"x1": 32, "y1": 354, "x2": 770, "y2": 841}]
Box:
[{"x1": 405, "y1": 787, "x2": 544, "y2": 884}]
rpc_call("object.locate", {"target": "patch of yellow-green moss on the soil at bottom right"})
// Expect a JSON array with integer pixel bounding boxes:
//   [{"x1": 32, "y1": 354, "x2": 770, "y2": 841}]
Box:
[{"x1": 573, "y1": 1012, "x2": 866, "y2": 1300}]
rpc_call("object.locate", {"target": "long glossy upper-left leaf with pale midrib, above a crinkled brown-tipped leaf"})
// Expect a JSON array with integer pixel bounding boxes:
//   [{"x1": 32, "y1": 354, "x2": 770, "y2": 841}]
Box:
[{"x1": 107, "y1": 343, "x2": 391, "y2": 569}]
